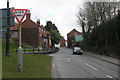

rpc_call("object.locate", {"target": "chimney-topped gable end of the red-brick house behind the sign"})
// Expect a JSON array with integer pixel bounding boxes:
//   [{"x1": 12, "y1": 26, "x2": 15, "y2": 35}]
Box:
[{"x1": 21, "y1": 12, "x2": 40, "y2": 48}]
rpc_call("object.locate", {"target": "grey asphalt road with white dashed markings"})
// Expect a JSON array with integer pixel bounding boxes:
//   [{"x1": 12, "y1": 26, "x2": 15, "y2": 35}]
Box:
[{"x1": 49, "y1": 48, "x2": 118, "y2": 80}]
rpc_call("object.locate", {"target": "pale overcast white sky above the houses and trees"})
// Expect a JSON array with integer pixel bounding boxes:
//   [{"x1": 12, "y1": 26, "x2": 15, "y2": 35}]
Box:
[{"x1": 0, "y1": 0, "x2": 83, "y2": 39}]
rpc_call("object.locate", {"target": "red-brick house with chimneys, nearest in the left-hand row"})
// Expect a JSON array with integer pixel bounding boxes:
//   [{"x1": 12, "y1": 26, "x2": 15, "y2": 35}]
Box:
[{"x1": 11, "y1": 13, "x2": 51, "y2": 49}]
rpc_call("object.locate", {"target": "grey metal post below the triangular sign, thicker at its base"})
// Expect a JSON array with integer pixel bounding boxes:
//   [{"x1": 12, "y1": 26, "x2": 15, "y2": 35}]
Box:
[{"x1": 18, "y1": 24, "x2": 22, "y2": 72}]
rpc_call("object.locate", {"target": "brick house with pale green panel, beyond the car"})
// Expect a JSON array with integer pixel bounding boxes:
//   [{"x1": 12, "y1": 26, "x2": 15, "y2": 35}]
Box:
[{"x1": 67, "y1": 29, "x2": 82, "y2": 48}]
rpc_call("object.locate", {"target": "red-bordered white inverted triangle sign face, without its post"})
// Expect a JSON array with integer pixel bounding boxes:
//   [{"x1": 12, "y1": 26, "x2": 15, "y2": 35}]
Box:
[{"x1": 10, "y1": 9, "x2": 28, "y2": 23}]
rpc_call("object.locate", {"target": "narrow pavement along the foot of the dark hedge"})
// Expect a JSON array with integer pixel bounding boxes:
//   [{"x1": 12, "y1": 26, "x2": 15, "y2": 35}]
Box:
[{"x1": 84, "y1": 52, "x2": 120, "y2": 66}]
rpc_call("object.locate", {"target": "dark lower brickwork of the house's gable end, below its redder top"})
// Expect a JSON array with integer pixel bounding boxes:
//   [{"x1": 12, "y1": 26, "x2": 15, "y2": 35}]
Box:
[{"x1": 22, "y1": 28, "x2": 39, "y2": 47}]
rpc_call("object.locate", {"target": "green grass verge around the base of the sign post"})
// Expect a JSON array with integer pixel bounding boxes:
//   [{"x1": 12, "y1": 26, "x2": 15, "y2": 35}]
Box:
[{"x1": 2, "y1": 42, "x2": 52, "y2": 78}]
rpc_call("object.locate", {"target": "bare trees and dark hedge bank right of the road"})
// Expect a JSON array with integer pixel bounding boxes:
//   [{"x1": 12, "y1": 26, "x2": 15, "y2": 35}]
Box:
[{"x1": 77, "y1": 0, "x2": 120, "y2": 52}]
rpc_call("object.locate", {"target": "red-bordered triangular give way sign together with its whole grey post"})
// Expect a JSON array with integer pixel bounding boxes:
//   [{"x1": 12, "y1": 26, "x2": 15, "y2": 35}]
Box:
[{"x1": 11, "y1": 9, "x2": 28, "y2": 72}]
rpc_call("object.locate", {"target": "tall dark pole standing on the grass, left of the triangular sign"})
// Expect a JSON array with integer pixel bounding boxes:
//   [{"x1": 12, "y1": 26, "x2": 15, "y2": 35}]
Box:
[{"x1": 5, "y1": 0, "x2": 10, "y2": 57}]
